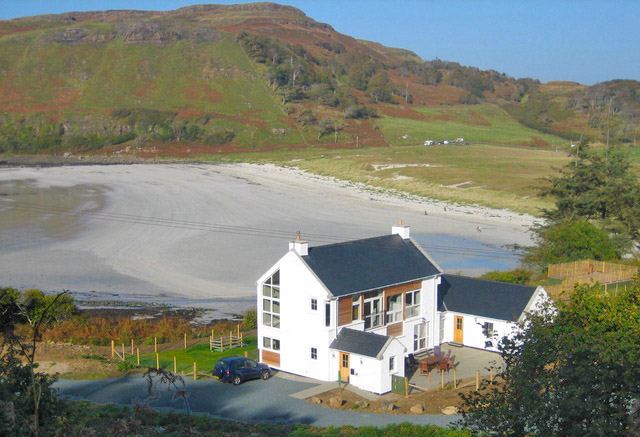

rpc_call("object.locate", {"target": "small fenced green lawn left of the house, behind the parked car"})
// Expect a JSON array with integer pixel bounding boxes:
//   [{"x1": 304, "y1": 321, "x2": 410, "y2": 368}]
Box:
[{"x1": 132, "y1": 337, "x2": 257, "y2": 374}]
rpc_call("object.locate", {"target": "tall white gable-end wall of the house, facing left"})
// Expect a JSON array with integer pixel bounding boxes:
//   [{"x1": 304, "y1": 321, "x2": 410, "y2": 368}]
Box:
[{"x1": 257, "y1": 251, "x2": 337, "y2": 381}]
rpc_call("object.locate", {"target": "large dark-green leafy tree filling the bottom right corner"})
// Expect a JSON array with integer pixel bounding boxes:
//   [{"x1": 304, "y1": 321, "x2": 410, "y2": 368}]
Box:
[{"x1": 461, "y1": 282, "x2": 640, "y2": 436}]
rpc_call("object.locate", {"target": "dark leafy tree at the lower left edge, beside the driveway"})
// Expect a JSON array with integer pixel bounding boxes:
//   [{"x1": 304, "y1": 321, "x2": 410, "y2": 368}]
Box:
[{"x1": 0, "y1": 288, "x2": 76, "y2": 436}]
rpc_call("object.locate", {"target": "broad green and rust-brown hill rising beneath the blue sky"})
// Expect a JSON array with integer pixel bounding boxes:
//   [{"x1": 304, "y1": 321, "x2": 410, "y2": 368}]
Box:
[{"x1": 0, "y1": 3, "x2": 639, "y2": 156}]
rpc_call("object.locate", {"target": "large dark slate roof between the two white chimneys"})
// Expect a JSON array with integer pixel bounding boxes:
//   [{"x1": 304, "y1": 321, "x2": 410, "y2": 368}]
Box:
[{"x1": 302, "y1": 235, "x2": 440, "y2": 296}]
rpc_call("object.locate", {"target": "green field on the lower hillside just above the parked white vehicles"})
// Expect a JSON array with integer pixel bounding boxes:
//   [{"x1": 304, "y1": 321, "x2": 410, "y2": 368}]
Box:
[{"x1": 377, "y1": 104, "x2": 568, "y2": 146}]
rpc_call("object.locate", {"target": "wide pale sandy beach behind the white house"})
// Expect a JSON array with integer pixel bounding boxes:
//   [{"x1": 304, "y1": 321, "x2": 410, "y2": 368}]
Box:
[{"x1": 0, "y1": 164, "x2": 534, "y2": 306}]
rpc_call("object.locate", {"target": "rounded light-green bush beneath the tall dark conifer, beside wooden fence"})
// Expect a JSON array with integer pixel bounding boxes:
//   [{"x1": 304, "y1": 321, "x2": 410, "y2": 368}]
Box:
[{"x1": 523, "y1": 220, "x2": 625, "y2": 269}]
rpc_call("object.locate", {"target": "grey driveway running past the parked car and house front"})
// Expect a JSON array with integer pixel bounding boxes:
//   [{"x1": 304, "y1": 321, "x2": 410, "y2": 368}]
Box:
[{"x1": 56, "y1": 375, "x2": 457, "y2": 427}]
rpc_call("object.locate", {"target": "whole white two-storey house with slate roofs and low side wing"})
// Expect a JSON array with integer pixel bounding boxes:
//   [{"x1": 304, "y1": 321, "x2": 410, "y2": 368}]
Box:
[{"x1": 257, "y1": 225, "x2": 546, "y2": 393}]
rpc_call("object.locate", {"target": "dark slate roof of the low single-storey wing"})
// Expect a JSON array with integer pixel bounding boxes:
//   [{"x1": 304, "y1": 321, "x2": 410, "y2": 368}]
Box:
[{"x1": 438, "y1": 274, "x2": 536, "y2": 321}]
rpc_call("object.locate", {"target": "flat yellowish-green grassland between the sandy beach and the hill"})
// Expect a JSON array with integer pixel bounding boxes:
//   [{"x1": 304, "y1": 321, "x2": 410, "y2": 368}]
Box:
[{"x1": 203, "y1": 145, "x2": 569, "y2": 214}]
